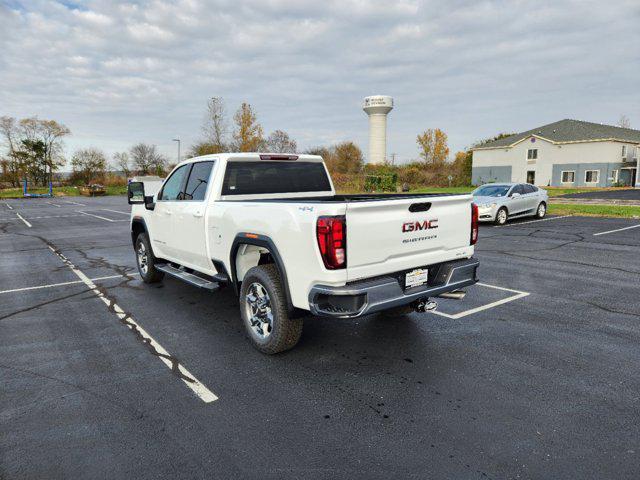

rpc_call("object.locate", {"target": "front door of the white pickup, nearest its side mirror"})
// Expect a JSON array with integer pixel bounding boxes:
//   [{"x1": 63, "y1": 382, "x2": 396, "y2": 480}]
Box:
[{"x1": 150, "y1": 165, "x2": 190, "y2": 259}]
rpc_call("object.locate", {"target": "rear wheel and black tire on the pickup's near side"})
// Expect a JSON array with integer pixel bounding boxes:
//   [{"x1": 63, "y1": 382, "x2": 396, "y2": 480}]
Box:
[{"x1": 240, "y1": 264, "x2": 302, "y2": 355}]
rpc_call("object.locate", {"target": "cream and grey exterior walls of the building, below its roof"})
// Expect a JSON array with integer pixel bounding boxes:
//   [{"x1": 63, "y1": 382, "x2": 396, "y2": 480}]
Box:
[{"x1": 472, "y1": 137, "x2": 633, "y2": 187}]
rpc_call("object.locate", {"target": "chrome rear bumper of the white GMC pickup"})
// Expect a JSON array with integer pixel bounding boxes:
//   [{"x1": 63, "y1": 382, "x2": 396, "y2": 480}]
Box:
[{"x1": 309, "y1": 258, "x2": 480, "y2": 318}]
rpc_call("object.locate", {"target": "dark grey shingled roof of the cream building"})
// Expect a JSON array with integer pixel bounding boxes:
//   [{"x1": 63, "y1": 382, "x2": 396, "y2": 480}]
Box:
[{"x1": 474, "y1": 118, "x2": 640, "y2": 150}]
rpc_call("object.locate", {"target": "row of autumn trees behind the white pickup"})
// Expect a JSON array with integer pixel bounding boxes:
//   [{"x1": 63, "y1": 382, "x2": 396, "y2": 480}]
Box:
[{"x1": 0, "y1": 97, "x2": 528, "y2": 190}]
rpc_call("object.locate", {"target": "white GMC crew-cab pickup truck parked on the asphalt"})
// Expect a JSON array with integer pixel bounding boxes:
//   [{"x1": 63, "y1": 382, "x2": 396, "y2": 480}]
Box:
[{"x1": 128, "y1": 153, "x2": 478, "y2": 353}]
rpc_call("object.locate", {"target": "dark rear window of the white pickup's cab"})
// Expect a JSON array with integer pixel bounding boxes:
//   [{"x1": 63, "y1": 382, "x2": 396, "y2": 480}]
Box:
[{"x1": 222, "y1": 160, "x2": 331, "y2": 195}]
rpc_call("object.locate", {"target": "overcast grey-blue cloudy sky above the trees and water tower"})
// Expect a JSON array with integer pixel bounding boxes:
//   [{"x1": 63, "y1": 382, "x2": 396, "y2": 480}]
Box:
[{"x1": 0, "y1": 0, "x2": 640, "y2": 166}]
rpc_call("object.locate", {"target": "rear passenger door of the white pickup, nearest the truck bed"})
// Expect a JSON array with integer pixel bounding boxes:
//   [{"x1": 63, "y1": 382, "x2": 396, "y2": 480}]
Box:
[{"x1": 171, "y1": 161, "x2": 215, "y2": 271}]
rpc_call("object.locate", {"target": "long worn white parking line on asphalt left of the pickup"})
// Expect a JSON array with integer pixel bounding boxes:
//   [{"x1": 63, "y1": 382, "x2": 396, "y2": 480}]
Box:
[{"x1": 49, "y1": 246, "x2": 218, "y2": 403}]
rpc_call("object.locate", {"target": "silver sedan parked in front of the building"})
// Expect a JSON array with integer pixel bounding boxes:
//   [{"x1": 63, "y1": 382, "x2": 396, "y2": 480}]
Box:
[{"x1": 473, "y1": 183, "x2": 549, "y2": 225}]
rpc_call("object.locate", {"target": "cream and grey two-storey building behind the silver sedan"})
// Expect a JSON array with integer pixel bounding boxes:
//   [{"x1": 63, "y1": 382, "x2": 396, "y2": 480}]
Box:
[{"x1": 472, "y1": 120, "x2": 640, "y2": 188}]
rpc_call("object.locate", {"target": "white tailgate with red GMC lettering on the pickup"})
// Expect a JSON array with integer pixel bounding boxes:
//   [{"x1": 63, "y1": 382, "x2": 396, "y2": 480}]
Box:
[{"x1": 346, "y1": 195, "x2": 473, "y2": 280}]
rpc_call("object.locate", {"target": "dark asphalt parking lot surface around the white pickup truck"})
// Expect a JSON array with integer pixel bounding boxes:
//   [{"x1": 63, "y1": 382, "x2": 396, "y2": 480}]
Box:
[{"x1": 0, "y1": 197, "x2": 640, "y2": 479}]
